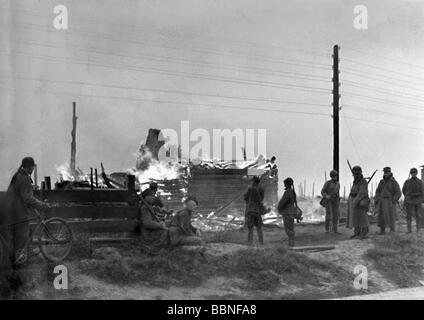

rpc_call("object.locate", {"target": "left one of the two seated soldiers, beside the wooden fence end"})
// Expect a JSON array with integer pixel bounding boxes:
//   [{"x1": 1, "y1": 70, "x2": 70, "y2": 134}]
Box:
[{"x1": 140, "y1": 191, "x2": 169, "y2": 255}]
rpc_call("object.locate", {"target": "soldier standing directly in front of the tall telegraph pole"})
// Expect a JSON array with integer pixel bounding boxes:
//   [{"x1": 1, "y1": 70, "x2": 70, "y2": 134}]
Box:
[{"x1": 321, "y1": 170, "x2": 340, "y2": 233}]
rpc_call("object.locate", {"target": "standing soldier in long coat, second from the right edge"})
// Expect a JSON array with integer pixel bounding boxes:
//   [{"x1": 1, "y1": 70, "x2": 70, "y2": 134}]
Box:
[{"x1": 375, "y1": 167, "x2": 402, "y2": 234}]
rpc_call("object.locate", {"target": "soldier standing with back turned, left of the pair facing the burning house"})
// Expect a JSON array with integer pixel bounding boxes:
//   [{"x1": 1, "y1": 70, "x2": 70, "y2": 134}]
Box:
[{"x1": 244, "y1": 177, "x2": 265, "y2": 245}]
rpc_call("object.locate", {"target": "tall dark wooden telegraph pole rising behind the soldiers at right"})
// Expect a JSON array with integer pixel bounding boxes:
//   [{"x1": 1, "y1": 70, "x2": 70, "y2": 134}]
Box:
[{"x1": 333, "y1": 45, "x2": 340, "y2": 172}]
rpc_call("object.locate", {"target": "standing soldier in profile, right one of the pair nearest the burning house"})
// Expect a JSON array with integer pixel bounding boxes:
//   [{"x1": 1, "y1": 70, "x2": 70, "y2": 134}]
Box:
[{"x1": 278, "y1": 178, "x2": 297, "y2": 247}]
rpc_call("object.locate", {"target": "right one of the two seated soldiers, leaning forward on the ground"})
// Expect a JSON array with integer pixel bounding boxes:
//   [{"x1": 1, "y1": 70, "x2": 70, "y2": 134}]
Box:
[{"x1": 169, "y1": 196, "x2": 203, "y2": 246}]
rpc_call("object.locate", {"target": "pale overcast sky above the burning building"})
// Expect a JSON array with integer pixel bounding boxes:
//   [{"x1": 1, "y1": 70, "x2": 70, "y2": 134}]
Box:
[{"x1": 0, "y1": 0, "x2": 424, "y2": 193}]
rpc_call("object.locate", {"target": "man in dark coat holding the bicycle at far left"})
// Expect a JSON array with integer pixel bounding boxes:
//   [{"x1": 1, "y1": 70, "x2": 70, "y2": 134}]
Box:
[{"x1": 1, "y1": 157, "x2": 50, "y2": 265}]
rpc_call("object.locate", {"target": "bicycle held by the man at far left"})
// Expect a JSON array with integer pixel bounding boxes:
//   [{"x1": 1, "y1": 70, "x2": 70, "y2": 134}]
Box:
[{"x1": 0, "y1": 209, "x2": 73, "y2": 263}]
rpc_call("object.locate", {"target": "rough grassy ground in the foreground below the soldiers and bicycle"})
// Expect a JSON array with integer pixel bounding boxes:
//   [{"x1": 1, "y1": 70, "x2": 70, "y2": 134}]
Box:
[{"x1": 3, "y1": 225, "x2": 424, "y2": 300}]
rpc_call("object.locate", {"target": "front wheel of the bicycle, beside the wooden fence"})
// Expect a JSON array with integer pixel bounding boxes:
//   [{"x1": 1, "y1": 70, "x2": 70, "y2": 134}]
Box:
[{"x1": 38, "y1": 218, "x2": 73, "y2": 262}]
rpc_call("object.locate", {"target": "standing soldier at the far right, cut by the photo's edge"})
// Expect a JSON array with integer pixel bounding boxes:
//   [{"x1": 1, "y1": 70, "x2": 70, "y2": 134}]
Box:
[{"x1": 402, "y1": 168, "x2": 424, "y2": 233}]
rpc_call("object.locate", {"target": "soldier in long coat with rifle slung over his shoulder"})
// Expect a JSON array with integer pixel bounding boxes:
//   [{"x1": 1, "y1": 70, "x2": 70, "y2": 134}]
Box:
[{"x1": 347, "y1": 166, "x2": 370, "y2": 240}]
